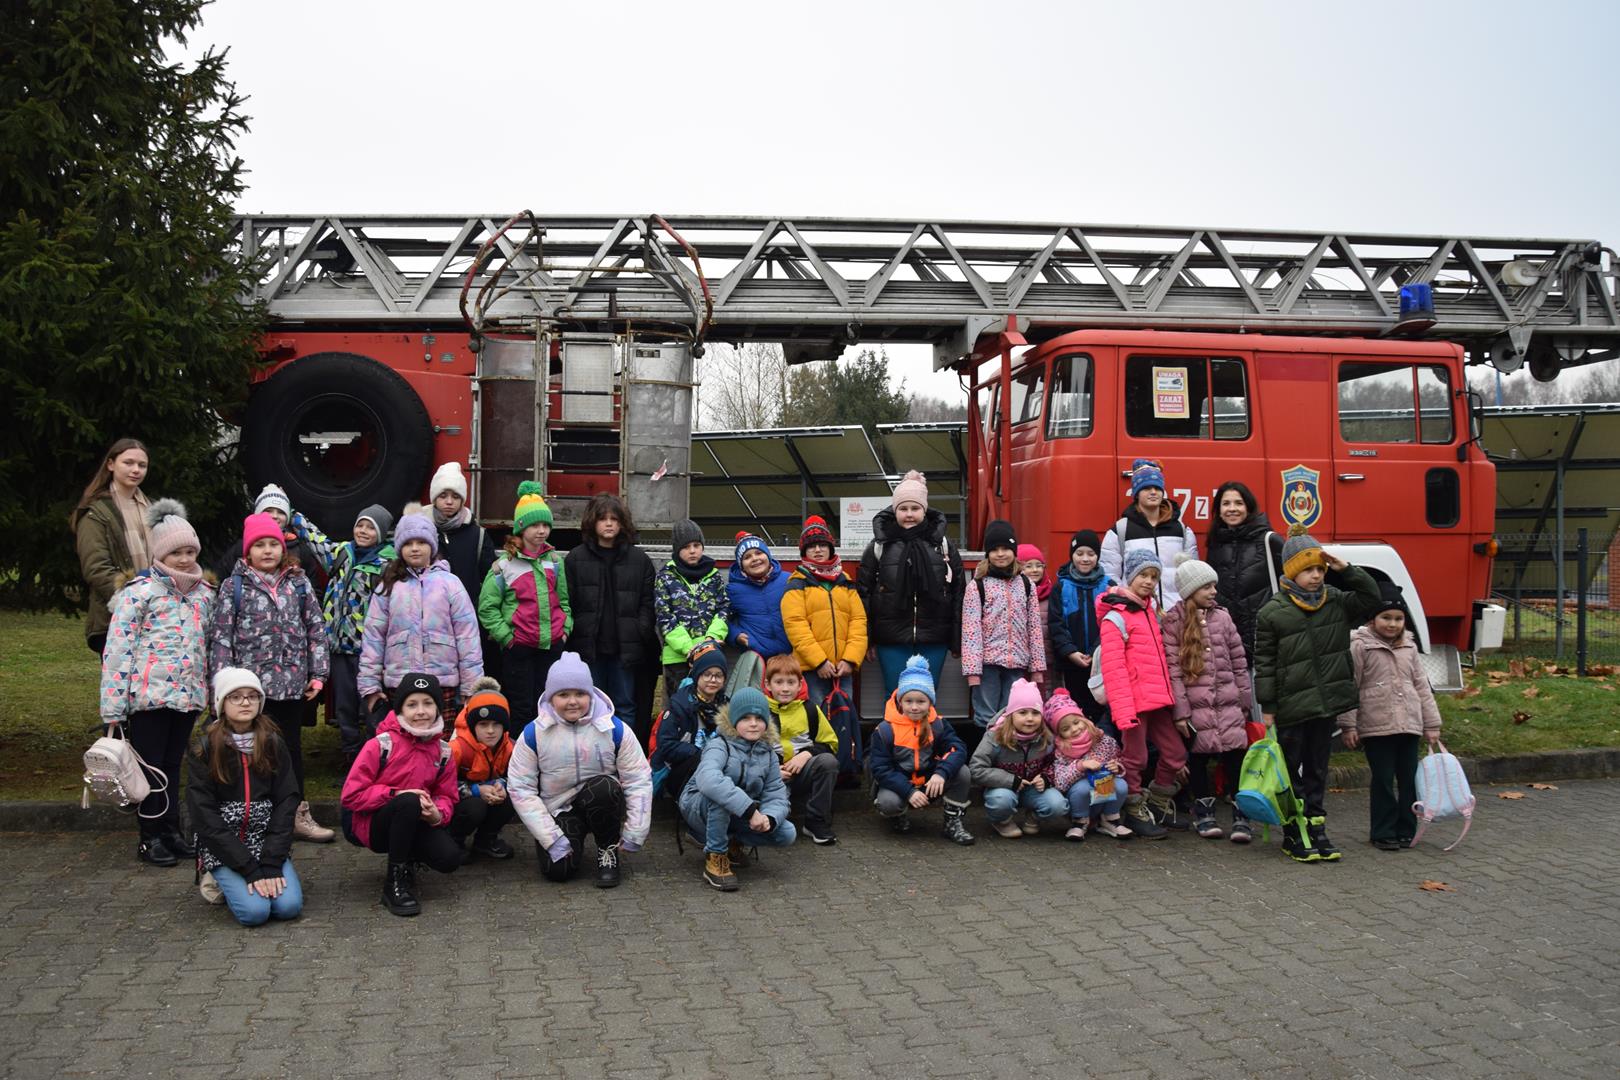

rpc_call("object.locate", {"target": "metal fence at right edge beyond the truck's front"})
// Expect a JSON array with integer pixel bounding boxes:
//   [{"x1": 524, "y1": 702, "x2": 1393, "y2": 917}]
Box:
[{"x1": 1494, "y1": 529, "x2": 1620, "y2": 675}]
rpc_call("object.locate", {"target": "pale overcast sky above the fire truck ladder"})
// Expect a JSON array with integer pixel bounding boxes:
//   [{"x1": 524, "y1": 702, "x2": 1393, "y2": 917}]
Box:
[{"x1": 191, "y1": 0, "x2": 1620, "y2": 392}]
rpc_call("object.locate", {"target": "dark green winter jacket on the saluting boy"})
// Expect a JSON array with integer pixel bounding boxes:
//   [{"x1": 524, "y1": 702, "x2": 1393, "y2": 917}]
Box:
[{"x1": 1254, "y1": 567, "x2": 1382, "y2": 727}]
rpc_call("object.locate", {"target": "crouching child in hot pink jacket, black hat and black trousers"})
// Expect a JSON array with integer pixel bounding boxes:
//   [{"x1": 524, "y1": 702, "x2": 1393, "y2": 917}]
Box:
[{"x1": 340, "y1": 672, "x2": 463, "y2": 915}]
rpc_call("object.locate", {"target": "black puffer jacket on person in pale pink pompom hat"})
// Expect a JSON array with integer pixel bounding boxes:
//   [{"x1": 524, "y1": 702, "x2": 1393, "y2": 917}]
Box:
[{"x1": 855, "y1": 508, "x2": 964, "y2": 649}]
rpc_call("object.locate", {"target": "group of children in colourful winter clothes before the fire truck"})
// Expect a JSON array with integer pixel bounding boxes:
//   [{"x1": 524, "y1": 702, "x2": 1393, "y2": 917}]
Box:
[{"x1": 102, "y1": 453, "x2": 1439, "y2": 923}]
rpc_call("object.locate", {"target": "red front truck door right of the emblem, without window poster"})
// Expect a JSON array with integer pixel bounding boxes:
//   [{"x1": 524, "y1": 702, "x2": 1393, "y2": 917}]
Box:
[{"x1": 1333, "y1": 356, "x2": 1473, "y2": 634}]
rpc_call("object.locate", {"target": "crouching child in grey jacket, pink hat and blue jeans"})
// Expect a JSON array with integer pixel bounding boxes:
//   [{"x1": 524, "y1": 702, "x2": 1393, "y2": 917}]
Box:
[{"x1": 969, "y1": 678, "x2": 1069, "y2": 840}]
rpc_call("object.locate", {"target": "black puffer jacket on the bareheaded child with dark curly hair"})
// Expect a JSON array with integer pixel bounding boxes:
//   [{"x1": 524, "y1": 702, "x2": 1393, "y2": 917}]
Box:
[{"x1": 562, "y1": 539, "x2": 658, "y2": 667}]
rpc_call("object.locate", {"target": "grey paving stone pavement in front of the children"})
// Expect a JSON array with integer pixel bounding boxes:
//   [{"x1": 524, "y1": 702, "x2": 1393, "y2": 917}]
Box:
[{"x1": 0, "y1": 782, "x2": 1620, "y2": 1080}]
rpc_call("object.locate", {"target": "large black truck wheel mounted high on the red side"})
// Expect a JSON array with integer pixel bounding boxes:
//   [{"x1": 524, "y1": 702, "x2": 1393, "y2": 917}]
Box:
[{"x1": 241, "y1": 353, "x2": 433, "y2": 534}]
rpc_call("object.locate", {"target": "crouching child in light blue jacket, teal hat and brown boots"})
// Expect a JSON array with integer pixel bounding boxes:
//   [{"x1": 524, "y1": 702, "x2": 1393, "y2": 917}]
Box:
[{"x1": 680, "y1": 687, "x2": 797, "y2": 892}]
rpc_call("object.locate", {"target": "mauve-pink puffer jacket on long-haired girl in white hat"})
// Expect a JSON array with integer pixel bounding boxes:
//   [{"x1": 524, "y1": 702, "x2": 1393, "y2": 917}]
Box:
[{"x1": 1165, "y1": 604, "x2": 1254, "y2": 755}]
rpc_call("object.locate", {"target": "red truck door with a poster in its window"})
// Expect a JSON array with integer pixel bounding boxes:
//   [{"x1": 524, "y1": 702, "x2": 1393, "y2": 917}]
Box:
[{"x1": 1115, "y1": 350, "x2": 1265, "y2": 537}]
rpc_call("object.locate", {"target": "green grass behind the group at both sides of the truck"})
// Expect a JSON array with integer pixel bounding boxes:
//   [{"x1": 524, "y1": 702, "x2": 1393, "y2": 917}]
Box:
[{"x1": 0, "y1": 610, "x2": 1620, "y2": 801}]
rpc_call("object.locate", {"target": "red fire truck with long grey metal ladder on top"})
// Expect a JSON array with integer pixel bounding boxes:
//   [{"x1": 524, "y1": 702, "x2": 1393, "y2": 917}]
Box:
[{"x1": 238, "y1": 212, "x2": 1620, "y2": 682}]
